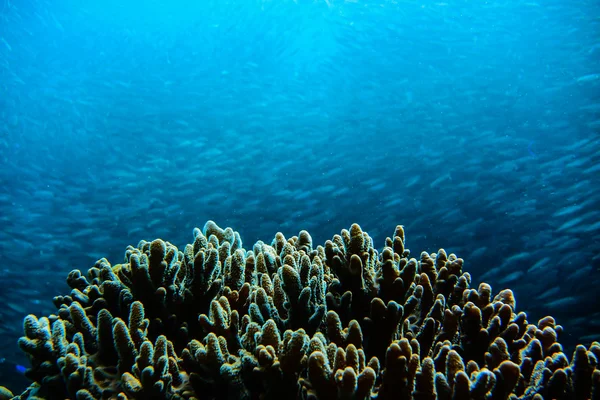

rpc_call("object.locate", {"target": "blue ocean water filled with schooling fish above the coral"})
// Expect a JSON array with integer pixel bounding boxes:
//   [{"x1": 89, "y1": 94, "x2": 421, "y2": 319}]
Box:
[{"x1": 0, "y1": 0, "x2": 600, "y2": 394}]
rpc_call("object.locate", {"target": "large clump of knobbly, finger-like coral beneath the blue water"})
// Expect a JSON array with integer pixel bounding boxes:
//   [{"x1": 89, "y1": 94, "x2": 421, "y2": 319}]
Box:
[{"x1": 0, "y1": 222, "x2": 600, "y2": 400}]
